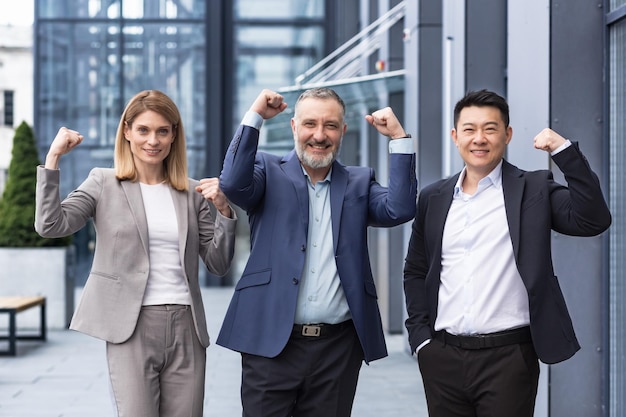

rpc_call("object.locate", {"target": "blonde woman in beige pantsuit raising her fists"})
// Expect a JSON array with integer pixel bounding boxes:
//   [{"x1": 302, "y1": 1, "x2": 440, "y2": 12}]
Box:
[{"x1": 35, "y1": 90, "x2": 236, "y2": 417}]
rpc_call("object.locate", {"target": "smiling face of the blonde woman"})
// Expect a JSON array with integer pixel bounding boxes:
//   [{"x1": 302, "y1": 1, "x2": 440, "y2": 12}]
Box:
[{"x1": 124, "y1": 110, "x2": 174, "y2": 183}]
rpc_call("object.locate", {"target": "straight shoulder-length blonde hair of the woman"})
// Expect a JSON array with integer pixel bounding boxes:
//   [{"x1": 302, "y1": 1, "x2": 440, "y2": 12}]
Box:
[{"x1": 113, "y1": 90, "x2": 189, "y2": 191}]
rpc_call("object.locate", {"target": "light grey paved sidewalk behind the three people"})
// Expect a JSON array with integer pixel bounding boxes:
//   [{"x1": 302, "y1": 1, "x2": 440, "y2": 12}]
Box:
[{"x1": 0, "y1": 287, "x2": 427, "y2": 417}]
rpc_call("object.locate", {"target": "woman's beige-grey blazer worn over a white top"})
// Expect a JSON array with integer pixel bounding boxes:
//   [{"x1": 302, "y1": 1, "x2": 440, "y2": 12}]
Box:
[{"x1": 35, "y1": 166, "x2": 236, "y2": 347}]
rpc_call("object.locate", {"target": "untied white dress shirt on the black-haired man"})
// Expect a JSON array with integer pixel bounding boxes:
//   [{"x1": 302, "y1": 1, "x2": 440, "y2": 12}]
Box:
[{"x1": 435, "y1": 162, "x2": 530, "y2": 335}]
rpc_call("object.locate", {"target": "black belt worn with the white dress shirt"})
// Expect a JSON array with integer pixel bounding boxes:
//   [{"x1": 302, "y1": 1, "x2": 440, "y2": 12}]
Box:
[{"x1": 434, "y1": 326, "x2": 532, "y2": 350}]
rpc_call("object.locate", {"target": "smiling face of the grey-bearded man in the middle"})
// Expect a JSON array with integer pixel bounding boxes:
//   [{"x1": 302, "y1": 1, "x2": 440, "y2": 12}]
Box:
[{"x1": 291, "y1": 98, "x2": 347, "y2": 180}]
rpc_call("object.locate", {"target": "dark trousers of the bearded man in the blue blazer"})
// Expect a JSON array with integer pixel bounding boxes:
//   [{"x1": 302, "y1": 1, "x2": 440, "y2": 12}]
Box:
[{"x1": 241, "y1": 323, "x2": 363, "y2": 417}]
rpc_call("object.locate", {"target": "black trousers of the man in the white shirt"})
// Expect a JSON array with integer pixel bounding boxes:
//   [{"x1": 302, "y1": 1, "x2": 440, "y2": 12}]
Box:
[{"x1": 418, "y1": 339, "x2": 539, "y2": 417}]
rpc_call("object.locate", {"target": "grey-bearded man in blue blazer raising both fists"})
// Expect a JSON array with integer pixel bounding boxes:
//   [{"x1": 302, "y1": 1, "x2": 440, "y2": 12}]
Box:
[{"x1": 217, "y1": 88, "x2": 417, "y2": 417}]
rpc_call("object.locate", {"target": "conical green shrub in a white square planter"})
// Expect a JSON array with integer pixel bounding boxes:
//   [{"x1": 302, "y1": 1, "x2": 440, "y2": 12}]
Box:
[{"x1": 0, "y1": 122, "x2": 75, "y2": 328}]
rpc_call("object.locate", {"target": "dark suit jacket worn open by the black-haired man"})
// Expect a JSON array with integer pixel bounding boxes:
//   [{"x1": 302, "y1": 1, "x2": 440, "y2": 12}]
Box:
[{"x1": 404, "y1": 143, "x2": 611, "y2": 363}]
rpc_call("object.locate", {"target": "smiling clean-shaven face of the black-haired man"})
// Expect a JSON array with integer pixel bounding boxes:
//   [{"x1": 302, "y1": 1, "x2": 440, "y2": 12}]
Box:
[{"x1": 452, "y1": 106, "x2": 513, "y2": 179}]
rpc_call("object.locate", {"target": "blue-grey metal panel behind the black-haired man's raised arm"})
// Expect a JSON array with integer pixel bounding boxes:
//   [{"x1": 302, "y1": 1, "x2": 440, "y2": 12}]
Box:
[{"x1": 550, "y1": 0, "x2": 608, "y2": 417}]
